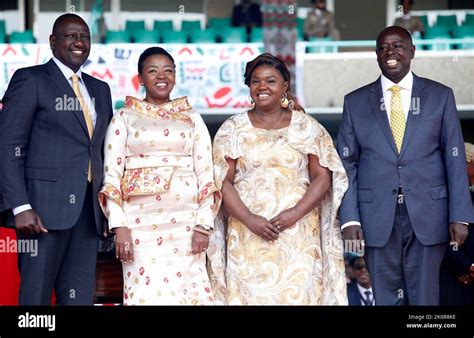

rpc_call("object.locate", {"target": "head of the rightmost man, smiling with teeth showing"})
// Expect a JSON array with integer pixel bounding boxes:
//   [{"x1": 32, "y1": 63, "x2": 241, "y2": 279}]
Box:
[{"x1": 376, "y1": 26, "x2": 415, "y2": 83}]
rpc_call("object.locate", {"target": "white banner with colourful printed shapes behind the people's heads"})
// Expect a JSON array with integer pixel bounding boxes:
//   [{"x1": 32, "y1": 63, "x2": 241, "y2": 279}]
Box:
[{"x1": 0, "y1": 43, "x2": 263, "y2": 109}]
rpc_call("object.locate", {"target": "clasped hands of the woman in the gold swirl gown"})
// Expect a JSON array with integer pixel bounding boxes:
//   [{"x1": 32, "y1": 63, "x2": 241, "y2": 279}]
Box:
[{"x1": 243, "y1": 207, "x2": 301, "y2": 242}]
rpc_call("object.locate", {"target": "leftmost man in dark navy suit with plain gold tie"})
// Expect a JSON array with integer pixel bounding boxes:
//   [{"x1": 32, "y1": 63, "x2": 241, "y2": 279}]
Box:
[{"x1": 0, "y1": 13, "x2": 112, "y2": 305}]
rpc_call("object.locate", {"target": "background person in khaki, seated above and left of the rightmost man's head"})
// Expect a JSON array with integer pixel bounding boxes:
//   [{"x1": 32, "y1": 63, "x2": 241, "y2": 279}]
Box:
[{"x1": 303, "y1": 0, "x2": 340, "y2": 40}]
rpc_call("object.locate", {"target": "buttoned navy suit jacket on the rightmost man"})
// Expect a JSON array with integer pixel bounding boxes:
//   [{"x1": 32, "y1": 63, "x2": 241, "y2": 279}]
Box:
[{"x1": 337, "y1": 75, "x2": 474, "y2": 247}]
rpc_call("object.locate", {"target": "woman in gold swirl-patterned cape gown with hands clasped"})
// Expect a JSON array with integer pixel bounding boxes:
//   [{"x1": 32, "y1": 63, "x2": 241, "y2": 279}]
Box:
[{"x1": 209, "y1": 53, "x2": 348, "y2": 305}]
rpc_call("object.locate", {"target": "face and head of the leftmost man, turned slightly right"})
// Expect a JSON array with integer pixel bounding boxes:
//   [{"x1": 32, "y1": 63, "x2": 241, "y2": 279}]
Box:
[{"x1": 49, "y1": 16, "x2": 91, "y2": 72}]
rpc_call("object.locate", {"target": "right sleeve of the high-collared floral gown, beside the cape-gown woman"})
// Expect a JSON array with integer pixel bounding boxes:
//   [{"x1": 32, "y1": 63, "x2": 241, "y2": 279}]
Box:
[{"x1": 193, "y1": 114, "x2": 221, "y2": 229}]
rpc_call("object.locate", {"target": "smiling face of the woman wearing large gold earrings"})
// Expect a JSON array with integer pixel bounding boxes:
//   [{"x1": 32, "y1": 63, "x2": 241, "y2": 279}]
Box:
[{"x1": 250, "y1": 65, "x2": 288, "y2": 112}]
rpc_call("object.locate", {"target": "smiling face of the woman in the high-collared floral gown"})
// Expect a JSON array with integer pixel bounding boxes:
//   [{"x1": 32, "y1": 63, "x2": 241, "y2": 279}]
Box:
[{"x1": 138, "y1": 54, "x2": 176, "y2": 105}]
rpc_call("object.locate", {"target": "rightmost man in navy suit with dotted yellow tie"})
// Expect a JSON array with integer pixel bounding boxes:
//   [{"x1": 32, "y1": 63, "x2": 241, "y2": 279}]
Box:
[{"x1": 338, "y1": 26, "x2": 474, "y2": 305}]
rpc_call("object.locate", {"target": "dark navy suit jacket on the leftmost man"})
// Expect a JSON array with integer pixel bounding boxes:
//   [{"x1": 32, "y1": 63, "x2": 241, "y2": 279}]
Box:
[{"x1": 0, "y1": 60, "x2": 112, "y2": 234}]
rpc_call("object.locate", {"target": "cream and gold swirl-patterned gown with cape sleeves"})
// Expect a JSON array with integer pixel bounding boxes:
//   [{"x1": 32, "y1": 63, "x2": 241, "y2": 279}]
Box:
[{"x1": 210, "y1": 111, "x2": 348, "y2": 305}]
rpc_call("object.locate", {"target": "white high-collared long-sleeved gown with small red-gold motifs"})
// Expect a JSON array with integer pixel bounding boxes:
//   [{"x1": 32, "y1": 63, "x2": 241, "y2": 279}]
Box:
[{"x1": 99, "y1": 97, "x2": 219, "y2": 305}]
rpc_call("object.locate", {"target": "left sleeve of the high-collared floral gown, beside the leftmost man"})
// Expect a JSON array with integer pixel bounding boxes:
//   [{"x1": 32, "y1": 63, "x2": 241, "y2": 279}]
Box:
[{"x1": 99, "y1": 111, "x2": 128, "y2": 231}]
